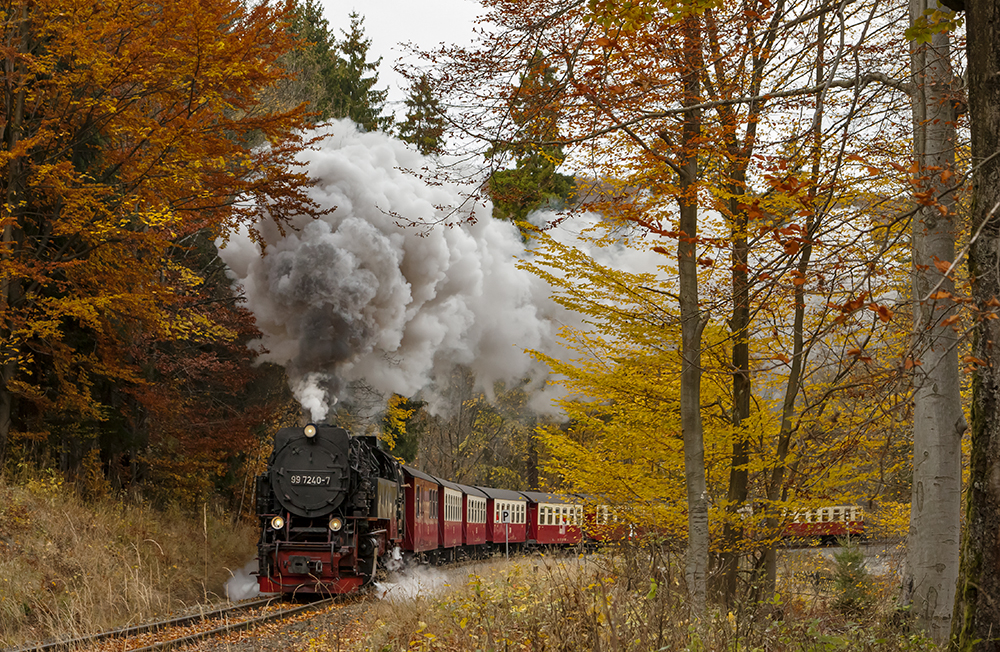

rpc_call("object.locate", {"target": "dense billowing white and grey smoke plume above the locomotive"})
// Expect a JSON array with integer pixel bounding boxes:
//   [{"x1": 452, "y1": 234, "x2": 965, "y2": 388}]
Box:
[{"x1": 221, "y1": 121, "x2": 559, "y2": 421}]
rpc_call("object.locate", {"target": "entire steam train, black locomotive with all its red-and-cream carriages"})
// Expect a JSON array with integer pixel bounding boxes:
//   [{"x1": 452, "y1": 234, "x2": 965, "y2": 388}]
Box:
[{"x1": 256, "y1": 424, "x2": 864, "y2": 594}]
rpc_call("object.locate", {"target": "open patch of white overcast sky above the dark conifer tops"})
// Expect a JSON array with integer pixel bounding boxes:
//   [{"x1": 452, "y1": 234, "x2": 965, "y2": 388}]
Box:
[{"x1": 321, "y1": 0, "x2": 482, "y2": 113}]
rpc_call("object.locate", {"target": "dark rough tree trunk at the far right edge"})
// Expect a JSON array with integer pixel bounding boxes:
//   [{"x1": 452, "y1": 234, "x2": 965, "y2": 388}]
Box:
[{"x1": 952, "y1": 0, "x2": 1000, "y2": 652}]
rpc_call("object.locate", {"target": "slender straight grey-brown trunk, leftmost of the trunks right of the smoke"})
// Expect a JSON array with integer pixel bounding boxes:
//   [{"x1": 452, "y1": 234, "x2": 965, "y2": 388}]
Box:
[{"x1": 677, "y1": 17, "x2": 708, "y2": 618}]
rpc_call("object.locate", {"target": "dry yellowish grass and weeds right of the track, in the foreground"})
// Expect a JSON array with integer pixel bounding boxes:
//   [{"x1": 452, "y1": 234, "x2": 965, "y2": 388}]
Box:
[{"x1": 346, "y1": 549, "x2": 933, "y2": 652}]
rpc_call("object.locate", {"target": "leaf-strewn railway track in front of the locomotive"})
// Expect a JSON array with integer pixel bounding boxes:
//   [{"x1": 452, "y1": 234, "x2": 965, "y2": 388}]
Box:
[{"x1": 8, "y1": 598, "x2": 336, "y2": 652}]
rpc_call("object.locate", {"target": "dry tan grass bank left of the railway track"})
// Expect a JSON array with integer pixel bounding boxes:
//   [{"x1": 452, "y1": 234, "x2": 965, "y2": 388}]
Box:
[{"x1": 0, "y1": 475, "x2": 256, "y2": 648}]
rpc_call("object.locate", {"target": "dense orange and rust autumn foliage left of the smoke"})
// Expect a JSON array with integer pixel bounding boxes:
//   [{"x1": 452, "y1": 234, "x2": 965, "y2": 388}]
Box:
[{"x1": 0, "y1": 0, "x2": 314, "y2": 502}]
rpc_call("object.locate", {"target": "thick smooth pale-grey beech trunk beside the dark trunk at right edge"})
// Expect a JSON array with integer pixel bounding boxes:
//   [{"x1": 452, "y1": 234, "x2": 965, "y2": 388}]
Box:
[{"x1": 903, "y1": 0, "x2": 967, "y2": 645}]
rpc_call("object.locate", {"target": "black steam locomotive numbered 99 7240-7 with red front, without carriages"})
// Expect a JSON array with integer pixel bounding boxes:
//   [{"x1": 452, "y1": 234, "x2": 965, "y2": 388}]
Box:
[{"x1": 257, "y1": 424, "x2": 403, "y2": 594}]
